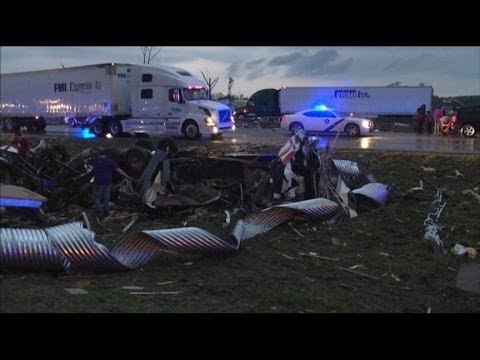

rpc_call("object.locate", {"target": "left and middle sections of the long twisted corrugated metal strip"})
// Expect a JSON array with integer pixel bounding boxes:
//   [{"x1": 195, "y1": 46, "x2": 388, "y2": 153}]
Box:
[{"x1": 0, "y1": 222, "x2": 240, "y2": 273}]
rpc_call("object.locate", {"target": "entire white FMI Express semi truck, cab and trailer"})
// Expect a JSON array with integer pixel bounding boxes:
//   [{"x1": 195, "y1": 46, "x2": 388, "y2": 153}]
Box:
[{"x1": 0, "y1": 63, "x2": 235, "y2": 139}]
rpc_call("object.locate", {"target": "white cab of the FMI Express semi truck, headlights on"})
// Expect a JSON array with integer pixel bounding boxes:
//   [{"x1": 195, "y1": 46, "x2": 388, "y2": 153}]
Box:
[{"x1": 119, "y1": 66, "x2": 235, "y2": 139}]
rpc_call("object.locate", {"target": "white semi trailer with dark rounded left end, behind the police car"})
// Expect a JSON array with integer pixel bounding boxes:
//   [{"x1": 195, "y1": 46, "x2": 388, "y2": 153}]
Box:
[{"x1": 244, "y1": 86, "x2": 433, "y2": 118}]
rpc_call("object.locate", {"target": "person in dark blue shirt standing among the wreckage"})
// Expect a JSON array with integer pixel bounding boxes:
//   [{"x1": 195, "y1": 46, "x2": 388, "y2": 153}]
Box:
[{"x1": 87, "y1": 150, "x2": 133, "y2": 224}]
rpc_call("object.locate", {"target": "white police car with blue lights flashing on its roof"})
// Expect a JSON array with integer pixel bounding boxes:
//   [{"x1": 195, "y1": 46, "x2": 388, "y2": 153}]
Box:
[{"x1": 280, "y1": 108, "x2": 373, "y2": 137}]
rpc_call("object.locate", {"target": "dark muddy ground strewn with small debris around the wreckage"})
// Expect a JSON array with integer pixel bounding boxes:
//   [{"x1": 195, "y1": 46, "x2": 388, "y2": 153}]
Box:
[{"x1": 0, "y1": 137, "x2": 480, "y2": 313}]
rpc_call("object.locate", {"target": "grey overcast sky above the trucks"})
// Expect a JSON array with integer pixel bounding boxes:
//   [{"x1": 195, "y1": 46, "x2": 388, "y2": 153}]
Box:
[{"x1": 0, "y1": 46, "x2": 480, "y2": 96}]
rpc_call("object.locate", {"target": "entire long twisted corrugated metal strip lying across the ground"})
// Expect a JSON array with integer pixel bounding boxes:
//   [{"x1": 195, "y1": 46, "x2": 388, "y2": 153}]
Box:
[{"x1": 0, "y1": 199, "x2": 342, "y2": 273}]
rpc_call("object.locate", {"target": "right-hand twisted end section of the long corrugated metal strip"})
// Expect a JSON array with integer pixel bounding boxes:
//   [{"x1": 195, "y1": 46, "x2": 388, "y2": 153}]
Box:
[{"x1": 232, "y1": 198, "x2": 343, "y2": 242}]
